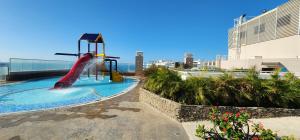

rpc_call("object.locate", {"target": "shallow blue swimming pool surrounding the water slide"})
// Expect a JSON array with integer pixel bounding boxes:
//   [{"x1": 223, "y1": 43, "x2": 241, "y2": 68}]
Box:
[{"x1": 0, "y1": 76, "x2": 137, "y2": 114}]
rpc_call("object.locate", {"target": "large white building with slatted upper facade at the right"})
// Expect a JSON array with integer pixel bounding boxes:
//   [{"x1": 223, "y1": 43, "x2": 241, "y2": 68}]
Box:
[{"x1": 221, "y1": 0, "x2": 300, "y2": 76}]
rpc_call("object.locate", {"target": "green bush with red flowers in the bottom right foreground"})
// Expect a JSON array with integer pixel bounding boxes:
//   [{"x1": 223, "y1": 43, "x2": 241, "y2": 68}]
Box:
[{"x1": 196, "y1": 109, "x2": 294, "y2": 140}]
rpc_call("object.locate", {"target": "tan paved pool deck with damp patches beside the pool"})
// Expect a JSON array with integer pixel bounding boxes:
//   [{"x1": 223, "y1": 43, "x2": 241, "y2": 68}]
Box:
[{"x1": 0, "y1": 84, "x2": 188, "y2": 140}]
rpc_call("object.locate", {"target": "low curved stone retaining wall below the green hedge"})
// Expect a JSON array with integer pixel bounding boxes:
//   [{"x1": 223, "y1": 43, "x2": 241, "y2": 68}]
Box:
[{"x1": 140, "y1": 88, "x2": 300, "y2": 122}]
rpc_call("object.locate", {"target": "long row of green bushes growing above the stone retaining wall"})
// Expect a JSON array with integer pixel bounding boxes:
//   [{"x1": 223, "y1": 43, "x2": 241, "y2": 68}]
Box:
[{"x1": 144, "y1": 67, "x2": 300, "y2": 108}]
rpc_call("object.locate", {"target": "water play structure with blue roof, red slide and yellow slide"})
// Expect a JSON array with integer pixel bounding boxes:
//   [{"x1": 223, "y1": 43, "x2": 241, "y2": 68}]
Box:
[{"x1": 54, "y1": 33, "x2": 123, "y2": 88}]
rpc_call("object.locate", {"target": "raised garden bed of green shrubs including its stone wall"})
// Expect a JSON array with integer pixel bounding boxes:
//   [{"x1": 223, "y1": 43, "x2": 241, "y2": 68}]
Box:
[{"x1": 140, "y1": 67, "x2": 300, "y2": 121}]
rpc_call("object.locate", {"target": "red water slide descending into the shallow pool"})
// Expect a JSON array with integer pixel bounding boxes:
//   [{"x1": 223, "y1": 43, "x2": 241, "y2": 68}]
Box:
[{"x1": 54, "y1": 53, "x2": 93, "y2": 89}]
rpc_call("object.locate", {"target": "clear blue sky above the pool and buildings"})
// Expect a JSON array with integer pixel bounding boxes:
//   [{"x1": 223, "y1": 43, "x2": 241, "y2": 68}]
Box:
[{"x1": 0, "y1": 0, "x2": 287, "y2": 63}]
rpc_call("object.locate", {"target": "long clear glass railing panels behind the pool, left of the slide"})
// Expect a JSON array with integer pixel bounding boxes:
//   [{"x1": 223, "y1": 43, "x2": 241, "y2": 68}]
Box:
[{"x1": 9, "y1": 58, "x2": 74, "y2": 72}]
